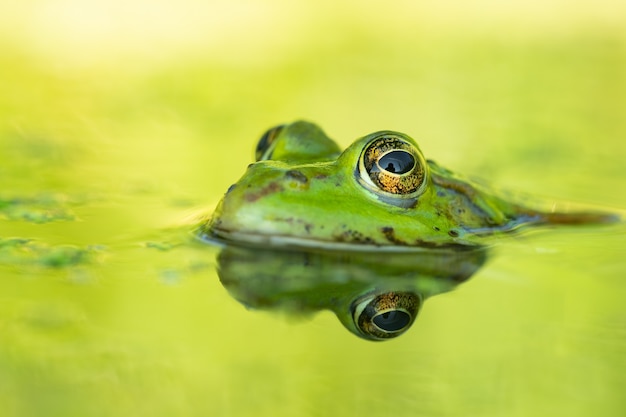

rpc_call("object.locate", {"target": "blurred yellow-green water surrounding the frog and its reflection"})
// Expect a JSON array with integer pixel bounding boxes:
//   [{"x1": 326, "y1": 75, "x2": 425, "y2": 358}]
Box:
[{"x1": 0, "y1": 0, "x2": 626, "y2": 416}]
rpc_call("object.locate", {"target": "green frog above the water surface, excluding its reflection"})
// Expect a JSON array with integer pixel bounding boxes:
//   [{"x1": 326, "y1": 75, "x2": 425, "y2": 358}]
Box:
[{"x1": 200, "y1": 121, "x2": 618, "y2": 252}]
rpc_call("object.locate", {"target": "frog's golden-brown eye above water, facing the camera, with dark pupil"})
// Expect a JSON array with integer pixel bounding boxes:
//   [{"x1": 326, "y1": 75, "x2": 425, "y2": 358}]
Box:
[{"x1": 358, "y1": 134, "x2": 426, "y2": 207}]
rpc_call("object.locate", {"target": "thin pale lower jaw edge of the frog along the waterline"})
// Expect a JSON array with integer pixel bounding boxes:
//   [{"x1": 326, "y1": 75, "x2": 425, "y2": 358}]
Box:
[{"x1": 198, "y1": 227, "x2": 486, "y2": 253}]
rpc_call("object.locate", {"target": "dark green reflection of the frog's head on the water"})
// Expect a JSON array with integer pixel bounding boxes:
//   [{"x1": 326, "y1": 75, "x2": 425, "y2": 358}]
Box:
[{"x1": 218, "y1": 245, "x2": 486, "y2": 340}]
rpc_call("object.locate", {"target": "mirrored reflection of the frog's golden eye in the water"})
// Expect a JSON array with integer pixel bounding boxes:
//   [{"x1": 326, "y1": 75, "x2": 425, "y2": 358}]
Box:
[{"x1": 352, "y1": 292, "x2": 421, "y2": 340}]
